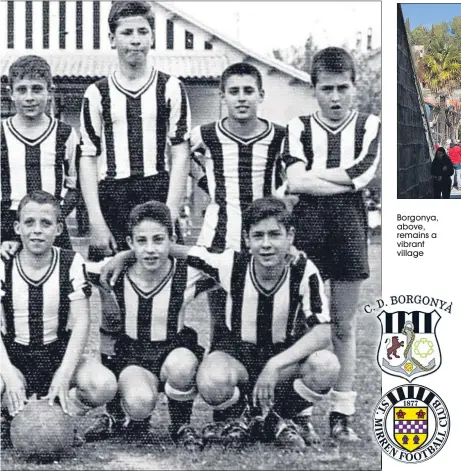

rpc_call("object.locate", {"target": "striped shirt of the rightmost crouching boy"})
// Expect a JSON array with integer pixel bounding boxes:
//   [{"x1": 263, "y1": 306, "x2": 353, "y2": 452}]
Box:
[{"x1": 187, "y1": 247, "x2": 330, "y2": 346}]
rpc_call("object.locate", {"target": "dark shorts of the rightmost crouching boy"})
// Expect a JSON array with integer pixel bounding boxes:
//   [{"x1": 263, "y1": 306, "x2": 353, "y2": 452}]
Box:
[{"x1": 210, "y1": 329, "x2": 289, "y2": 386}]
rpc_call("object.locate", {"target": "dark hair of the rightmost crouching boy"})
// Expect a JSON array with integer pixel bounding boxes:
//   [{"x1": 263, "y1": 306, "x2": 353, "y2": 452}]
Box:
[{"x1": 243, "y1": 196, "x2": 293, "y2": 234}]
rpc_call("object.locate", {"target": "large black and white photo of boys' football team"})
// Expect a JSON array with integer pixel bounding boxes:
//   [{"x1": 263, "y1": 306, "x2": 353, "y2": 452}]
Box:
[{"x1": 0, "y1": 0, "x2": 381, "y2": 470}]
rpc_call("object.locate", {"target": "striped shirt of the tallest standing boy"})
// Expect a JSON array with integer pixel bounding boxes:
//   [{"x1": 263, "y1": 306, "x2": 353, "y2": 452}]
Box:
[{"x1": 81, "y1": 69, "x2": 191, "y2": 180}]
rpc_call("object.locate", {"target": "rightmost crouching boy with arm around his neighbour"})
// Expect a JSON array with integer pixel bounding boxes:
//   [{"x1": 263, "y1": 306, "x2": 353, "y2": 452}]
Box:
[{"x1": 99, "y1": 197, "x2": 339, "y2": 449}]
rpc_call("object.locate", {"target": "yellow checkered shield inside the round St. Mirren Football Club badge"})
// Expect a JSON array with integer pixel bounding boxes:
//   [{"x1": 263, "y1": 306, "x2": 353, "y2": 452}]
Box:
[{"x1": 394, "y1": 407, "x2": 428, "y2": 451}]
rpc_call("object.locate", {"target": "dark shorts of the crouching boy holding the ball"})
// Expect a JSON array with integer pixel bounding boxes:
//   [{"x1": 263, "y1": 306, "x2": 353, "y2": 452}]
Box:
[{"x1": 5, "y1": 339, "x2": 68, "y2": 398}]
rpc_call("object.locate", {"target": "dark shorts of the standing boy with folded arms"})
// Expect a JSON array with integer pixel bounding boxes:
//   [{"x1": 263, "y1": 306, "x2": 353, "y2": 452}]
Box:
[{"x1": 293, "y1": 192, "x2": 370, "y2": 281}]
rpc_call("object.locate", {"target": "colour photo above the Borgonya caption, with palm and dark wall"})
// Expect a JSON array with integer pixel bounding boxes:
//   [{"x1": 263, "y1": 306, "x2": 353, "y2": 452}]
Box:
[{"x1": 397, "y1": 3, "x2": 461, "y2": 199}]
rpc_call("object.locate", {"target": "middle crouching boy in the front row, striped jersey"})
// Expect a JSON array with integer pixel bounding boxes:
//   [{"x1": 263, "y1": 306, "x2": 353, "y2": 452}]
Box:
[{"x1": 85, "y1": 201, "x2": 210, "y2": 450}]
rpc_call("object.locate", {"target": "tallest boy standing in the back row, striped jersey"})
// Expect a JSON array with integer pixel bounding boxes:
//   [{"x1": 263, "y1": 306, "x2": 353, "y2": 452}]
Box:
[{"x1": 79, "y1": 1, "x2": 190, "y2": 430}]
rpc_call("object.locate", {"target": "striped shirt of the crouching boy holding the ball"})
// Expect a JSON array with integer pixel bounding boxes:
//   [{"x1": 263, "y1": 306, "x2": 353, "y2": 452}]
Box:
[{"x1": 0, "y1": 251, "x2": 91, "y2": 346}]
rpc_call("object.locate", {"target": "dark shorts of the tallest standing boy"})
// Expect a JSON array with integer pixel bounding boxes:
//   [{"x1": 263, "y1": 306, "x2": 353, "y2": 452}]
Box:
[{"x1": 88, "y1": 172, "x2": 182, "y2": 261}]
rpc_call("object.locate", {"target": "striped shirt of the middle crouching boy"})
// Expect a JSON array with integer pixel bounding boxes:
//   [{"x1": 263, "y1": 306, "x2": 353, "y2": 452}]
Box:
[{"x1": 88, "y1": 259, "x2": 213, "y2": 342}]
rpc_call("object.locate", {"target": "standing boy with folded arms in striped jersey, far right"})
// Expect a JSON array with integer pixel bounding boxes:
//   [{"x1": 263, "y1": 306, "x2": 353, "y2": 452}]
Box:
[{"x1": 284, "y1": 47, "x2": 380, "y2": 441}]
